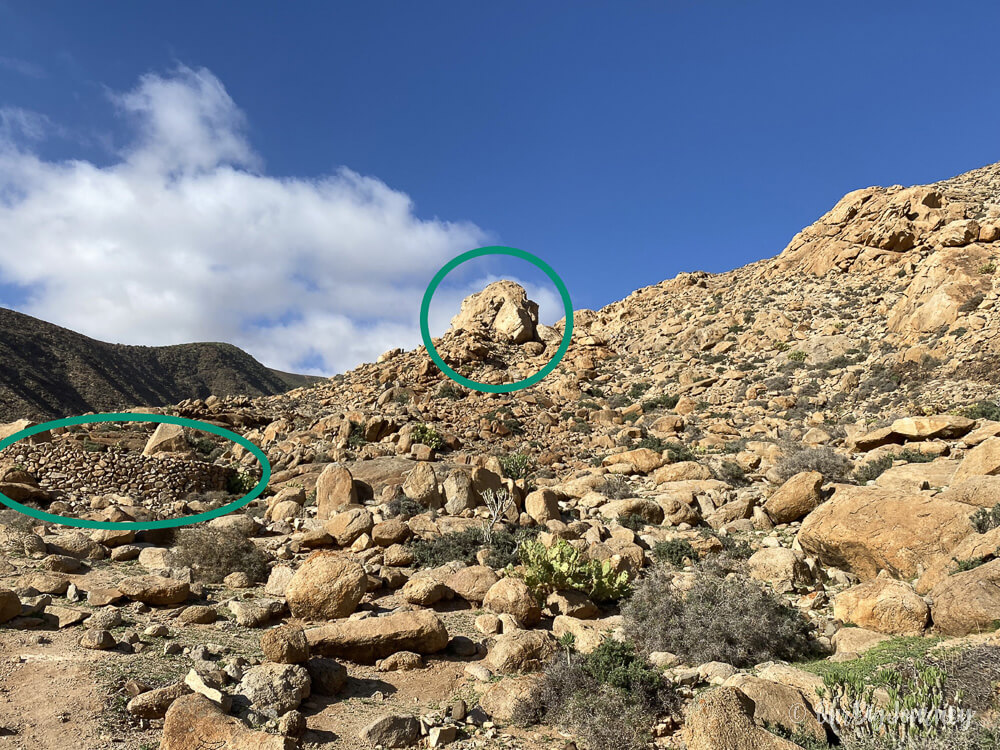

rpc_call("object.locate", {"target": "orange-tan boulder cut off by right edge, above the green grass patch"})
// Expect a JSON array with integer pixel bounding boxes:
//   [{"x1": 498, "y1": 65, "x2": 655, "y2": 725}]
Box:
[{"x1": 931, "y1": 560, "x2": 1000, "y2": 635}]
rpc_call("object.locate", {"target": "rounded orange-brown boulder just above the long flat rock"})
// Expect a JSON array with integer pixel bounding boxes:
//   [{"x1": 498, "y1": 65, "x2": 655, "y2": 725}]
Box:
[{"x1": 285, "y1": 550, "x2": 368, "y2": 620}]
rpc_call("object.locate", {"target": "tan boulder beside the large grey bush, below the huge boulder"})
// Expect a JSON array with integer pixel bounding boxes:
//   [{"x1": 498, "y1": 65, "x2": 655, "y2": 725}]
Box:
[{"x1": 833, "y1": 578, "x2": 930, "y2": 635}]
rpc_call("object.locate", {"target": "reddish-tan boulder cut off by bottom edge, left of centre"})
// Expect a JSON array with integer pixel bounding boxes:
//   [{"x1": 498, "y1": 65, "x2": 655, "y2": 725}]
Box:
[{"x1": 160, "y1": 693, "x2": 296, "y2": 750}]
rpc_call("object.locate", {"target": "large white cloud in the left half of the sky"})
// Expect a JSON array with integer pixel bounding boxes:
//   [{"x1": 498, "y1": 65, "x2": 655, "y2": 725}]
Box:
[{"x1": 0, "y1": 67, "x2": 489, "y2": 372}]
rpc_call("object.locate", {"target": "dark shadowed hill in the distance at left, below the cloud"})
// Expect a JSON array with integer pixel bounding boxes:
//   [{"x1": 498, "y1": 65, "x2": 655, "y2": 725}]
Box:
[{"x1": 0, "y1": 308, "x2": 320, "y2": 421}]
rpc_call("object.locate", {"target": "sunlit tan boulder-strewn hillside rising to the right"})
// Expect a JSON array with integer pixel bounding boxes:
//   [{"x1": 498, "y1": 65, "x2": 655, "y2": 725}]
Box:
[{"x1": 0, "y1": 160, "x2": 1000, "y2": 750}]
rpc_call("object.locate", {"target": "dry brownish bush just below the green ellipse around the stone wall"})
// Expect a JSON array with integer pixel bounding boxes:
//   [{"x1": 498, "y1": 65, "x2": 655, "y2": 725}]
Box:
[{"x1": 172, "y1": 527, "x2": 268, "y2": 583}]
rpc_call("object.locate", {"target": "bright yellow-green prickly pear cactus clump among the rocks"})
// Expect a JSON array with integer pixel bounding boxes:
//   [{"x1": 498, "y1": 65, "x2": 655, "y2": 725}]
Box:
[{"x1": 514, "y1": 539, "x2": 630, "y2": 602}]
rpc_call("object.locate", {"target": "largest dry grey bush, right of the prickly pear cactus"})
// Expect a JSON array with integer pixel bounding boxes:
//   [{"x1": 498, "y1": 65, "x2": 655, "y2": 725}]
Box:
[{"x1": 622, "y1": 565, "x2": 814, "y2": 668}]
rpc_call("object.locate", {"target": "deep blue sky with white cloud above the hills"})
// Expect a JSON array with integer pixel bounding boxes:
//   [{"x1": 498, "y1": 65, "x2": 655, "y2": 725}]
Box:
[{"x1": 0, "y1": 0, "x2": 1000, "y2": 371}]
